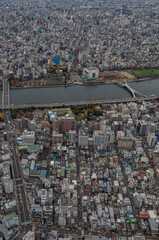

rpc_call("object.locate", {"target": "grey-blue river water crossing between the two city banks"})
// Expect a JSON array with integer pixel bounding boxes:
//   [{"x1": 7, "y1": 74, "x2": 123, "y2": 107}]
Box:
[{"x1": 0, "y1": 79, "x2": 159, "y2": 104}]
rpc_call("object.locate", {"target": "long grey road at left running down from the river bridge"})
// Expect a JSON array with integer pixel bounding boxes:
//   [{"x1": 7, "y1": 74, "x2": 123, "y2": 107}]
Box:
[{"x1": 2, "y1": 80, "x2": 32, "y2": 240}]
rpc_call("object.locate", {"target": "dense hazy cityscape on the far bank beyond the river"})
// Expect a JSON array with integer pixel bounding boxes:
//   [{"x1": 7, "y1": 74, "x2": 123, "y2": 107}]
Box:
[{"x1": 0, "y1": 0, "x2": 159, "y2": 86}]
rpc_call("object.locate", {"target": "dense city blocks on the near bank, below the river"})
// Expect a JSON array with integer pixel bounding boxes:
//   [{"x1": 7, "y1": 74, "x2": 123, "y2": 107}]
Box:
[{"x1": 0, "y1": 101, "x2": 159, "y2": 240}]
